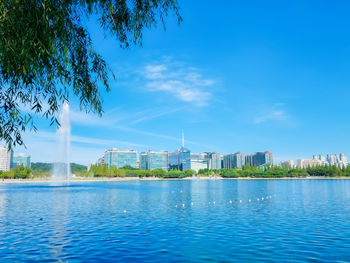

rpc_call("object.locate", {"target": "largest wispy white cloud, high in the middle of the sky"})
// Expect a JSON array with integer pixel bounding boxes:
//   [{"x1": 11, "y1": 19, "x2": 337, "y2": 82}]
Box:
[{"x1": 143, "y1": 63, "x2": 214, "y2": 106}]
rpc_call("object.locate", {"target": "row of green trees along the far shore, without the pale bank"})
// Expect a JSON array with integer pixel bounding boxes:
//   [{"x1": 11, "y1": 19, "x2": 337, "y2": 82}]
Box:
[{"x1": 0, "y1": 163, "x2": 350, "y2": 179}]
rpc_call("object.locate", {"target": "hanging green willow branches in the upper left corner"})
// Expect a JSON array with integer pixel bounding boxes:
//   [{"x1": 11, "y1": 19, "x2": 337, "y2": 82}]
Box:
[{"x1": 0, "y1": 0, "x2": 182, "y2": 147}]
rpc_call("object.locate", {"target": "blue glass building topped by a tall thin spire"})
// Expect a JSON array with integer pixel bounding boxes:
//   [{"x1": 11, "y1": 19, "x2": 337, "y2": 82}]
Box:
[{"x1": 169, "y1": 131, "x2": 191, "y2": 171}]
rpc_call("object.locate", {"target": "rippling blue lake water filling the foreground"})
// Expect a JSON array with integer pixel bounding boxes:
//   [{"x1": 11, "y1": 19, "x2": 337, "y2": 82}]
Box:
[{"x1": 0, "y1": 180, "x2": 350, "y2": 262}]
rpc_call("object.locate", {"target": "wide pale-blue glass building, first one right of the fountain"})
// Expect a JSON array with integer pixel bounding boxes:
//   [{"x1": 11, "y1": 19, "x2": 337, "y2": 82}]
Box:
[{"x1": 104, "y1": 149, "x2": 137, "y2": 168}]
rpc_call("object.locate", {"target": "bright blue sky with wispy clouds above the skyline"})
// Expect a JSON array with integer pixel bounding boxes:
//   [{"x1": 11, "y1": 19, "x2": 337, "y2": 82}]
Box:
[{"x1": 15, "y1": 0, "x2": 350, "y2": 164}]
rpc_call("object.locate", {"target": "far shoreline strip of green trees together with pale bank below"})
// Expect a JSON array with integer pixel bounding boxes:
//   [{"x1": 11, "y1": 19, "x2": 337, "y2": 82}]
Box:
[{"x1": 0, "y1": 163, "x2": 350, "y2": 182}]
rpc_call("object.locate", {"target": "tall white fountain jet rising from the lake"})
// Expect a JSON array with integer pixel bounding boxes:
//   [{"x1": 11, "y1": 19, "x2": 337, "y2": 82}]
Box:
[{"x1": 51, "y1": 101, "x2": 71, "y2": 181}]
